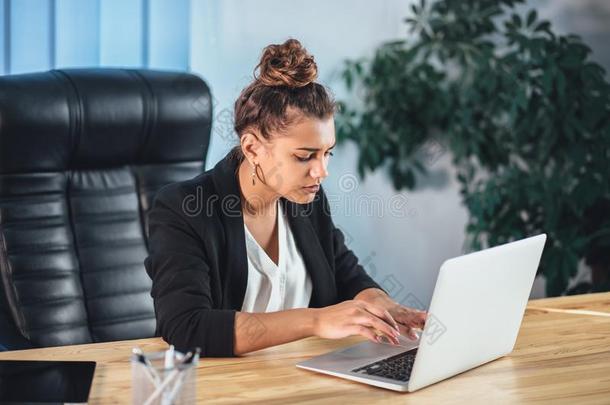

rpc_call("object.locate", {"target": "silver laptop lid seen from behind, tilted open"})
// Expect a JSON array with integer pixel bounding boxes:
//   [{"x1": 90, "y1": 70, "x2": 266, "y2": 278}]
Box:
[{"x1": 409, "y1": 234, "x2": 546, "y2": 391}]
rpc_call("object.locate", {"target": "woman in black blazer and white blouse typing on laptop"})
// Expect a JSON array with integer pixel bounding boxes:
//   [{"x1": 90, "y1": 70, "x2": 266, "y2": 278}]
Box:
[{"x1": 145, "y1": 39, "x2": 426, "y2": 356}]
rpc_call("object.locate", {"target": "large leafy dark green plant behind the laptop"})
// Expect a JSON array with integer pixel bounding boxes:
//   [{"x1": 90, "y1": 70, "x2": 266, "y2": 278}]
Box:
[{"x1": 337, "y1": 0, "x2": 610, "y2": 295}]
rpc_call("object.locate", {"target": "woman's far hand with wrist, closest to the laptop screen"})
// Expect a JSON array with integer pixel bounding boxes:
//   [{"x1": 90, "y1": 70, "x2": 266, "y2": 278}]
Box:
[{"x1": 354, "y1": 288, "x2": 428, "y2": 340}]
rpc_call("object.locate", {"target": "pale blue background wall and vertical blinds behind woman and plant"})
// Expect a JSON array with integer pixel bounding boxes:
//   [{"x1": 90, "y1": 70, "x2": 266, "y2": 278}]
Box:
[{"x1": 0, "y1": 0, "x2": 610, "y2": 306}]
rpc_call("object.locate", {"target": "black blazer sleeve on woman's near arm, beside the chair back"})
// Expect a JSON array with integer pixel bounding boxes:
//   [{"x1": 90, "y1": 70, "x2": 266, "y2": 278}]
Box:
[{"x1": 144, "y1": 184, "x2": 235, "y2": 357}]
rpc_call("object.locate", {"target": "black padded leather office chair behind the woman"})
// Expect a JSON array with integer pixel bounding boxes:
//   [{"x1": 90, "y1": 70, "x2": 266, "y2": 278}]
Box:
[{"x1": 0, "y1": 69, "x2": 212, "y2": 348}]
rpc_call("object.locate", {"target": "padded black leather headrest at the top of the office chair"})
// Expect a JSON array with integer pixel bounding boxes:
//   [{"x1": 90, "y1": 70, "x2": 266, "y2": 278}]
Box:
[{"x1": 0, "y1": 68, "x2": 212, "y2": 174}]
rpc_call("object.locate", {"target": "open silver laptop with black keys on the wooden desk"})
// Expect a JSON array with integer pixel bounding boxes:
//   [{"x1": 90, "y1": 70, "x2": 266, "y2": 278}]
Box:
[{"x1": 297, "y1": 234, "x2": 546, "y2": 392}]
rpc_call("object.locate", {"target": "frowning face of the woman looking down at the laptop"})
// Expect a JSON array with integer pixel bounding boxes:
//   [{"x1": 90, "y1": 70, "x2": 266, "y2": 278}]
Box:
[{"x1": 258, "y1": 116, "x2": 336, "y2": 204}]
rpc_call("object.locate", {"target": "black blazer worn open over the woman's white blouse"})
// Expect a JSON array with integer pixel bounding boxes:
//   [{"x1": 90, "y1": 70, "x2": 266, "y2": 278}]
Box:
[{"x1": 144, "y1": 153, "x2": 380, "y2": 356}]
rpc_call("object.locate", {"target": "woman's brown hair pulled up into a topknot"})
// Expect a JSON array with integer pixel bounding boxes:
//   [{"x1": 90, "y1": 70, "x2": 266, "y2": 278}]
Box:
[{"x1": 232, "y1": 39, "x2": 337, "y2": 160}]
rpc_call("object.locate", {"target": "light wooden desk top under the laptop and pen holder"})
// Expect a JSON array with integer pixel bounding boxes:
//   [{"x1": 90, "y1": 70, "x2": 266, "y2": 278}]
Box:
[{"x1": 0, "y1": 293, "x2": 610, "y2": 404}]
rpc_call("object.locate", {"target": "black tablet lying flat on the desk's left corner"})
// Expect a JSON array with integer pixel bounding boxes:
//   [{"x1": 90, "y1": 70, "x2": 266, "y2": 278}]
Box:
[{"x1": 0, "y1": 360, "x2": 95, "y2": 404}]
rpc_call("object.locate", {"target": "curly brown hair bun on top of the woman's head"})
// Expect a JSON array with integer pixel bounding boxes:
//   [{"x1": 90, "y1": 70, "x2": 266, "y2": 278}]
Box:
[{"x1": 254, "y1": 39, "x2": 318, "y2": 87}]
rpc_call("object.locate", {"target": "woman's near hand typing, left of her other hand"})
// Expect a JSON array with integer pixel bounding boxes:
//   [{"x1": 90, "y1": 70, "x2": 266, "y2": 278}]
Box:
[{"x1": 313, "y1": 300, "x2": 400, "y2": 344}]
